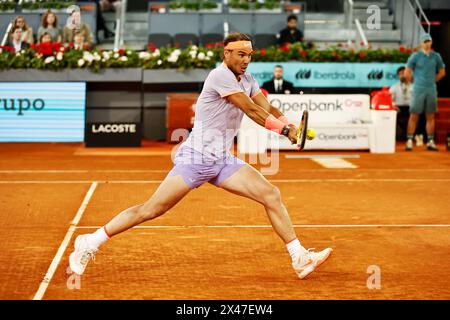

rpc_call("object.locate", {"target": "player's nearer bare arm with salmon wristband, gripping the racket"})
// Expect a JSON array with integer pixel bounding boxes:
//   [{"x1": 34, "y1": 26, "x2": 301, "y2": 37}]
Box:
[{"x1": 227, "y1": 92, "x2": 297, "y2": 143}]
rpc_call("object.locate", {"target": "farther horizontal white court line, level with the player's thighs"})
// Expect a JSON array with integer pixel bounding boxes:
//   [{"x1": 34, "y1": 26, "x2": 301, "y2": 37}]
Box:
[{"x1": 0, "y1": 178, "x2": 450, "y2": 184}]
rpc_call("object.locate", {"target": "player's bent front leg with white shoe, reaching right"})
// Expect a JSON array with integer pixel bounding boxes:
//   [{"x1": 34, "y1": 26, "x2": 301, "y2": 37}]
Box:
[{"x1": 219, "y1": 164, "x2": 333, "y2": 279}]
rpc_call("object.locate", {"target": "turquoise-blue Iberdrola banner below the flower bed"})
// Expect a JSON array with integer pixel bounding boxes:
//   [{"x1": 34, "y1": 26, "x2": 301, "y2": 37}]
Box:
[{"x1": 247, "y1": 62, "x2": 404, "y2": 88}]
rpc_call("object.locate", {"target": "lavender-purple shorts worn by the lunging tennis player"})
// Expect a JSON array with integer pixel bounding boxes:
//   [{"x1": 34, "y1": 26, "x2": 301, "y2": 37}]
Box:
[{"x1": 168, "y1": 146, "x2": 245, "y2": 189}]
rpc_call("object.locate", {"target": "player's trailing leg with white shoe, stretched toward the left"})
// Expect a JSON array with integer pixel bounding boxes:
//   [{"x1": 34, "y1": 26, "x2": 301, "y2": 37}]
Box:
[{"x1": 69, "y1": 176, "x2": 191, "y2": 275}]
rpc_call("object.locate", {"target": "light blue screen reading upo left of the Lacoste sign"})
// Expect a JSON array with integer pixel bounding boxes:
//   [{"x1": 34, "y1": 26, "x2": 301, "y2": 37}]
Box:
[{"x1": 0, "y1": 82, "x2": 86, "y2": 142}]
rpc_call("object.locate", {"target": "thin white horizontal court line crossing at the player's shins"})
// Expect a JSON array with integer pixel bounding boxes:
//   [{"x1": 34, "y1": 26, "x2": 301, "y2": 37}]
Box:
[{"x1": 76, "y1": 224, "x2": 450, "y2": 229}]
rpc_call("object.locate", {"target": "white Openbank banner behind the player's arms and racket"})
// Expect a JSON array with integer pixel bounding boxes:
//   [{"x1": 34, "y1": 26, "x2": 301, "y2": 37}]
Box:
[{"x1": 238, "y1": 94, "x2": 372, "y2": 153}]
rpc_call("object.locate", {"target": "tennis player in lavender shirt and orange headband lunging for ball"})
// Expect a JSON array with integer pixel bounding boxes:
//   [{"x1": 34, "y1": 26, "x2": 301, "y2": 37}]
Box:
[{"x1": 69, "y1": 33, "x2": 333, "y2": 279}]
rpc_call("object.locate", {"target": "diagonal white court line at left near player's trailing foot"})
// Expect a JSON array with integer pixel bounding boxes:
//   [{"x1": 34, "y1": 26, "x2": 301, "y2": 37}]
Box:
[{"x1": 33, "y1": 182, "x2": 97, "y2": 300}]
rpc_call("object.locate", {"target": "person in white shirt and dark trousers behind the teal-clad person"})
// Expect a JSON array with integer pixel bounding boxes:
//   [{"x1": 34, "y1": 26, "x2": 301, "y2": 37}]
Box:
[{"x1": 389, "y1": 67, "x2": 425, "y2": 146}]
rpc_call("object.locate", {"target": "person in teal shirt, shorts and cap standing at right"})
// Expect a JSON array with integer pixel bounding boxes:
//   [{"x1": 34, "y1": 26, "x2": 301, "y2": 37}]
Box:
[{"x1": 405, "y1": 33, "x2": 445, "y2": 151}]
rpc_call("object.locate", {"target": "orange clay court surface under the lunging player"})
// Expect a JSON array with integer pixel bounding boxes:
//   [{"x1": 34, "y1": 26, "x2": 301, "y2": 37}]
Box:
[{"x1": 0, "y1": 143, "x2": 450, "y2": 299}]
